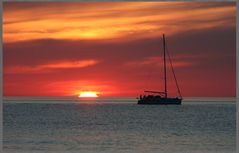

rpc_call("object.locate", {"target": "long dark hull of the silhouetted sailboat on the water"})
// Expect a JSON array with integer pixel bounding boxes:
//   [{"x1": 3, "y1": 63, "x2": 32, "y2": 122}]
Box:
[{"x1": 138, "y1": 98, "x2": 182, "y2": 105}]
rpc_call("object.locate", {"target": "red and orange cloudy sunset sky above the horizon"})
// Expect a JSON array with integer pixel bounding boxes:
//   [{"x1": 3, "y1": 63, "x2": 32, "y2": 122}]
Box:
[{"x1": 3, "y1": 2, "x2": 236, "y2": 97}]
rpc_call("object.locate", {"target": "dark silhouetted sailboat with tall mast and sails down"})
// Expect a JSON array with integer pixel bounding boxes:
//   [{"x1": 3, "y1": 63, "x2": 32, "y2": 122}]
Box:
[{"x1": 137, "y1": 34, "x2": 182, "y2": 105}]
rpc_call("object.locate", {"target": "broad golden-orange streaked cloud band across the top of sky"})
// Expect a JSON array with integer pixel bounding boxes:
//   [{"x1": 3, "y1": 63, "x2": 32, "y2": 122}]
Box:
[{"x1": 3, "y1": 2, "x2": 236, "y2": 42}]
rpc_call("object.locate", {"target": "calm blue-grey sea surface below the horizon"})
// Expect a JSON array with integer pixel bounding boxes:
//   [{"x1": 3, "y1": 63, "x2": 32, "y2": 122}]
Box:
[{"x1": 3, "y1": 100, "x2": 236, "y2": 153}]
